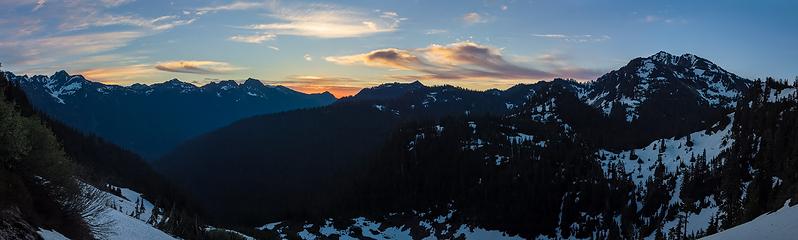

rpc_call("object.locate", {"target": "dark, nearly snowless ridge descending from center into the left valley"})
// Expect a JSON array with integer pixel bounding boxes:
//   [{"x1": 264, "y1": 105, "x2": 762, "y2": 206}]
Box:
[{"x1": 156, "y1": 81, "x2": 536, "y2": 224}]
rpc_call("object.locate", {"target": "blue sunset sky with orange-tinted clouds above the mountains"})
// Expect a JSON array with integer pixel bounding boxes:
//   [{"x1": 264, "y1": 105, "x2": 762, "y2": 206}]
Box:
[{"x1": 0, "y1": 0, "x2": 798, "y2": 97}]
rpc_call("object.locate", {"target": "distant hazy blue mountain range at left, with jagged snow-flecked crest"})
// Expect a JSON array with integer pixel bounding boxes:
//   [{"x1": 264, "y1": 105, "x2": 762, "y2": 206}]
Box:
[{"x1": 4, "y1": 71, "x2": 335, "y2": 159}]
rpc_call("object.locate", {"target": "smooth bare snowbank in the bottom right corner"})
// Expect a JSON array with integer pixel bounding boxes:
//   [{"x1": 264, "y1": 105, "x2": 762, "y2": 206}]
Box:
[{"x1": 704, "y1": 201, "x2": 798, "y2": 240}]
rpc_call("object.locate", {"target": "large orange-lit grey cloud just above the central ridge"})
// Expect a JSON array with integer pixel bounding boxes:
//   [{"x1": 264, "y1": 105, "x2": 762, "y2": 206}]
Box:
[{"x1": 326, "y1": 42, "x2": 554, "y2": 80}]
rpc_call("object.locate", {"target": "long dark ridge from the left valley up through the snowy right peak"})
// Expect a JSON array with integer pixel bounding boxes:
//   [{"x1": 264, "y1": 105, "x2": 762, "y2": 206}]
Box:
[{"x1": 155, "y1": 52, "x2": 753, "y2": 229}]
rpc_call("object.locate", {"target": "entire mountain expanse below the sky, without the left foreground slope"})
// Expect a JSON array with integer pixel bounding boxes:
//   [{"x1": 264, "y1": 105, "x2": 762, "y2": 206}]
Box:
[{"x1": 6, "y1": 52, "x2": 798, "y2": 239}]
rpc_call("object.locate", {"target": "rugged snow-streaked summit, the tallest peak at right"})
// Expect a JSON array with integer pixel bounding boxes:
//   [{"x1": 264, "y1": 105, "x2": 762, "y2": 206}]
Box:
[{"x1": 580, "y1": 51, "x2": 750, "y2": 122}]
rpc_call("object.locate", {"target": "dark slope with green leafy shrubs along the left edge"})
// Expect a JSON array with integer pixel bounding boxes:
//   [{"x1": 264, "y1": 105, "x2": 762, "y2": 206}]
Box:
[{"x1": 0, "y1": 78, "x2": 92, "y2": 239}]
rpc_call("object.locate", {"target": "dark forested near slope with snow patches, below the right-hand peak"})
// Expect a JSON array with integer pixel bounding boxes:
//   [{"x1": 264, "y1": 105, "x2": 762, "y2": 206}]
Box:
[{"x1": 340, "y1": 80, "x2": 798, "y2": 239}]
